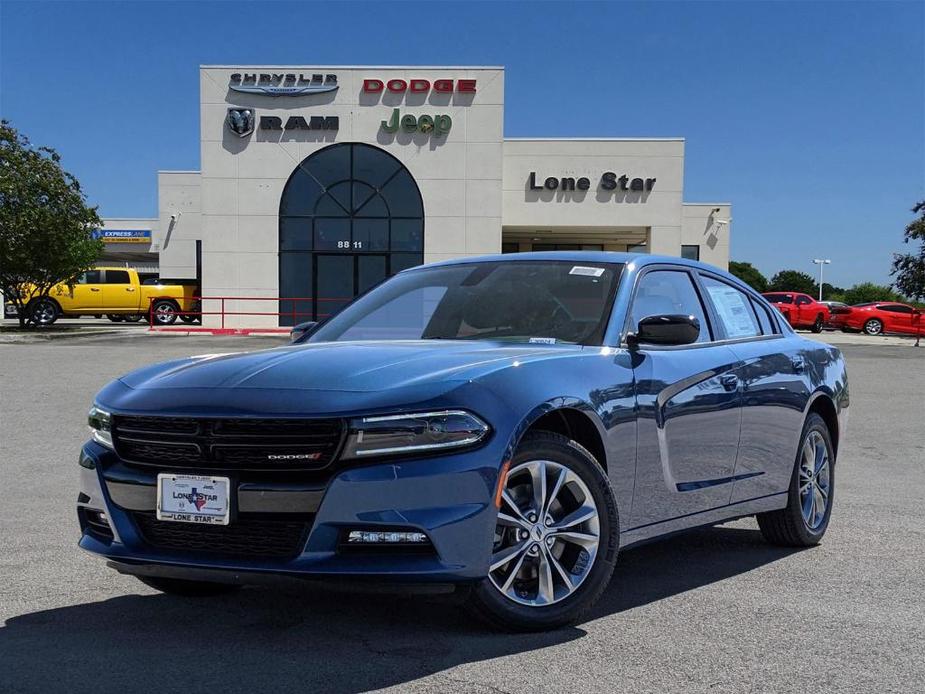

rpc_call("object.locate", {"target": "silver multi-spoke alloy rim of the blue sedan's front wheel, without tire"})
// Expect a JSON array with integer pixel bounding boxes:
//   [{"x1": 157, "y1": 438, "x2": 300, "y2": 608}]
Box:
[{"x1": 489, "y1": 460, "x2": 600, "y2": 607}]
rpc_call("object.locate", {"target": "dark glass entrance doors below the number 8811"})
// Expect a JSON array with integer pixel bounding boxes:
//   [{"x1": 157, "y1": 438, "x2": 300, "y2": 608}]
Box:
[{"x1": 312, "y1": 253, "x2": 389, "y2": 321}]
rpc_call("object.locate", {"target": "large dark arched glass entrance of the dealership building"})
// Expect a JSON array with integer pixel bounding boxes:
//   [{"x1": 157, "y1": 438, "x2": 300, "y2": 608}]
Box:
[{"x1": 279, "y1": 143, "x2": 424, "y2": 325}]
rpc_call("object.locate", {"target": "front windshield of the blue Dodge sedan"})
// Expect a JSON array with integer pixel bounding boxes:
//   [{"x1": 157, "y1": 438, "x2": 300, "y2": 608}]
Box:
[{"x1": 310, "y1": 260, "x2": 623, "y2": 344}]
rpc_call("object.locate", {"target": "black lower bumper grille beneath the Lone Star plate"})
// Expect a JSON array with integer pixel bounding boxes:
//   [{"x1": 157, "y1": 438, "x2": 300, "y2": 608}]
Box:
[{"x1": 132, "y1": 512, "x2": 311, "y2": 559}]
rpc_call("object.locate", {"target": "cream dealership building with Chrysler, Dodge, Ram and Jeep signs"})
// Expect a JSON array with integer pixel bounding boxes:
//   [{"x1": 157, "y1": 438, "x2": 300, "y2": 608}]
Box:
[{"x1": 108, "y1": 65, "x2": 731, "y2": 326}]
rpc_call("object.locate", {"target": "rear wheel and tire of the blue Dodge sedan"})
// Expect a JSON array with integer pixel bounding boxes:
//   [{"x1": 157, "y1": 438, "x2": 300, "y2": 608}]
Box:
[{"x1": 757, "y1": 412, "x2": 835, "y2": 547}]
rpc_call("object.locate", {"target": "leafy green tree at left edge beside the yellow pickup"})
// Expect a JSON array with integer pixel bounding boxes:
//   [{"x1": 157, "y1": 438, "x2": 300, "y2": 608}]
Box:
[{"x1": 0, "y1": 120, "x2": 103, "y2": 326}]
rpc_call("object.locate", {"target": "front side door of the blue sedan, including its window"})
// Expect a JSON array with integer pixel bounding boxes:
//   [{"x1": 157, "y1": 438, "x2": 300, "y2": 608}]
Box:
[{"x1": 628, "y1": 266, "x2": 740, "y2": 529}]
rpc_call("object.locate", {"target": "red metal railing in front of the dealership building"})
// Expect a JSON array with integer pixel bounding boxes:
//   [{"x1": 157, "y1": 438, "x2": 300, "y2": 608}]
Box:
[{"x1": 148, "y1": 296, "x2": 353, "y2": 335}]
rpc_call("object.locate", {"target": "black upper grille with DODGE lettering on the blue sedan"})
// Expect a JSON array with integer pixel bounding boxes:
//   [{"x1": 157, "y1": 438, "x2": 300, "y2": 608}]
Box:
[{"x1": 113, "y1": 415, "x2": 344, "y2": 470}]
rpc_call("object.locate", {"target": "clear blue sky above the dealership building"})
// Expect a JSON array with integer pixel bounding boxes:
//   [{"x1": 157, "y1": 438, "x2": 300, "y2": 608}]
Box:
[{"x1": 0, "y1": 0, "x2": 925, "y2": 285}]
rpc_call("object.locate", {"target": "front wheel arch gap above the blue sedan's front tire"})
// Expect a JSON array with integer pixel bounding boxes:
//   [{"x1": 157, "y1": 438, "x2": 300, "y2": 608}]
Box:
[{"x1": 508, "y1": 398, "x2": 607, "y2": 471}]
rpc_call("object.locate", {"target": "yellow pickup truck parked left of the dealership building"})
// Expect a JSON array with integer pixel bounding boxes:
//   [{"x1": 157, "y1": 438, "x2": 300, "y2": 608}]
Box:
[{"x1": 8, "y1": 267, "x2": 199, "y2": 325}]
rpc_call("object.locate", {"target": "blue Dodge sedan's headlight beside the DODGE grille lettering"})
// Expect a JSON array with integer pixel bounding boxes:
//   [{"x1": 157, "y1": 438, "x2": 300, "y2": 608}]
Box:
[{"x1": 343, "y1": 410, "x2": 489, "y2": 458}]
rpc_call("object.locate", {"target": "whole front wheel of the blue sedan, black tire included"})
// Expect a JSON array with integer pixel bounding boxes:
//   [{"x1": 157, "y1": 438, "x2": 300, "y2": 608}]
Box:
[{"x1": 467, "y1": 432, "x2": 620, "y2": 631}]
